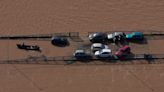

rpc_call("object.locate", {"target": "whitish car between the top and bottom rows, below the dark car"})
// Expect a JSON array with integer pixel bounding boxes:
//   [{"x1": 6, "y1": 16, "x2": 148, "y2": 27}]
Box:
[{"x1": 91, "y1": 43, "x2": 108, "y2": 52}]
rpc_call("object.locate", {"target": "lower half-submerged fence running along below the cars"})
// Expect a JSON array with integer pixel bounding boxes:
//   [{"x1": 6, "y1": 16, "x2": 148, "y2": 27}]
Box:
[{"x1": 0, "y1": 54, "x2": 164, "y2": 65}]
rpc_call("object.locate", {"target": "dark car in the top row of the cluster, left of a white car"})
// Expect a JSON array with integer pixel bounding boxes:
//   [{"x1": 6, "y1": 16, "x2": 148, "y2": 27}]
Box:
[{"x1": 89, "y1": 32, "x2": 107, "y2": 43}]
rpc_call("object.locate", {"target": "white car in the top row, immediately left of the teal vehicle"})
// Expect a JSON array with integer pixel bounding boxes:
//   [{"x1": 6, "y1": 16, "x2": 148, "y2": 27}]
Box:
[{"x1": 107, "y1": 32, "x2": 126, "y2": 41}]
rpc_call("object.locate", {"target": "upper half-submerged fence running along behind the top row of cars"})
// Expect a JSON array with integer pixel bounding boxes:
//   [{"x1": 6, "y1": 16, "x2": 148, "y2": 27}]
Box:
[{"x1": 0, "y1": 31, "x2": 164, "y2": 41}]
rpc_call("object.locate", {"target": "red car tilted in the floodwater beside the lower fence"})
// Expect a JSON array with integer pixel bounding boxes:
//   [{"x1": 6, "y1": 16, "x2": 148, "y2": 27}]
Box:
[{"x1": 115, "y1": 45, "x2": 131, "y2": 59}]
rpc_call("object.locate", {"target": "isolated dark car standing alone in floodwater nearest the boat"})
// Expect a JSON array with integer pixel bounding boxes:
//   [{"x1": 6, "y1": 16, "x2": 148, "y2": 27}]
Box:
[{"x1": 51, "y1": 36, "x2": 69, "y2": 47}]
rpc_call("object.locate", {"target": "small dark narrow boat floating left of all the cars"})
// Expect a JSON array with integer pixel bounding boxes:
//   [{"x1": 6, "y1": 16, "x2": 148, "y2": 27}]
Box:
[{"x1": 17, "y1": 43, "x2": 40, "y2": 51}]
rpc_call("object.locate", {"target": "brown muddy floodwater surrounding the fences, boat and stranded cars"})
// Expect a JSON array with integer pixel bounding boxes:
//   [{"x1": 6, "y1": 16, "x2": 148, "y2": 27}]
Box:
[{"x1": 0, "y1": 0, "x2": 164, "y2": 92}]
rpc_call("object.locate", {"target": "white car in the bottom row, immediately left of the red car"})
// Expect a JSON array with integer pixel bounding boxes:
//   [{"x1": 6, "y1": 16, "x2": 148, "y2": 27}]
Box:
[{"x1": 95, "y1": 49, "x2": 112, "y2": 58}]
